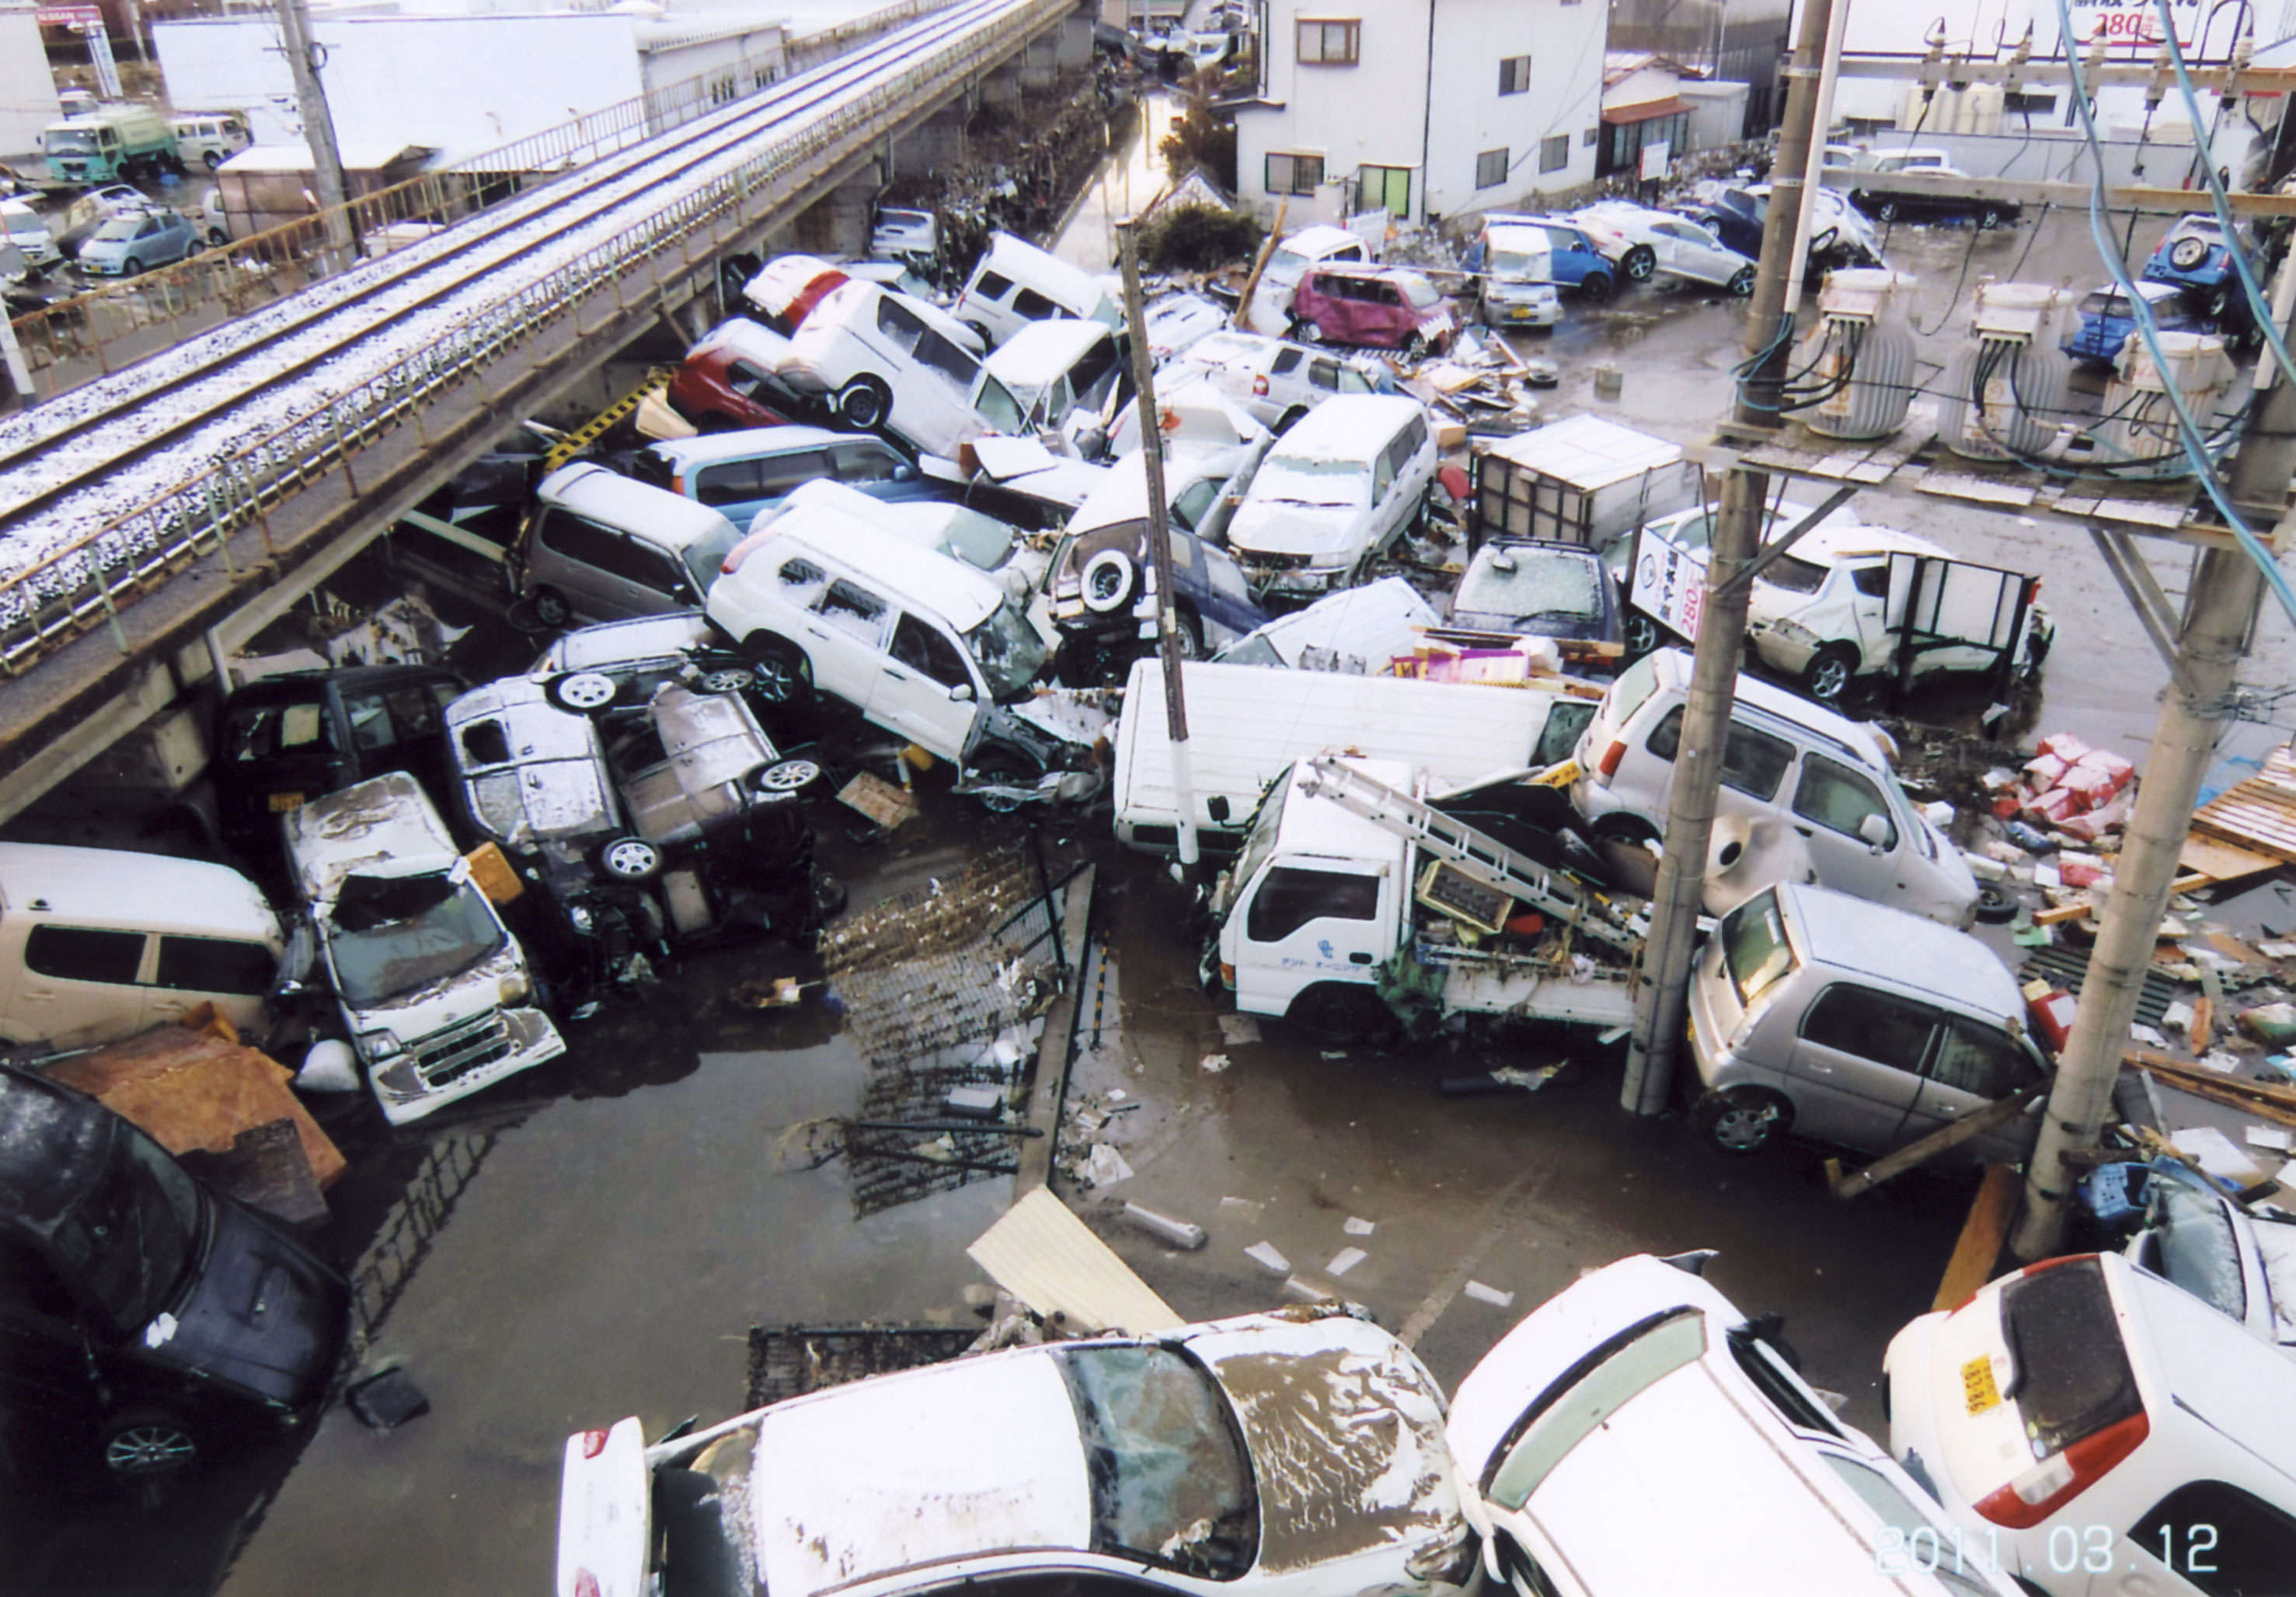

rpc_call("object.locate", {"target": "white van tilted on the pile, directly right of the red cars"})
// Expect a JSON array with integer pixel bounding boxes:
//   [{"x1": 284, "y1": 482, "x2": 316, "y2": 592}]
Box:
[{"x1": 776, "y1": 278, "x2": 1001, "y2": 457}]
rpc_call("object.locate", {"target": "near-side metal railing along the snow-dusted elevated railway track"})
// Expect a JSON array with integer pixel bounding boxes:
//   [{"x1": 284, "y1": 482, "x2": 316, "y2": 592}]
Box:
[{"x1": 0, "y1": 0, "x2": 1075, "y2": 675}]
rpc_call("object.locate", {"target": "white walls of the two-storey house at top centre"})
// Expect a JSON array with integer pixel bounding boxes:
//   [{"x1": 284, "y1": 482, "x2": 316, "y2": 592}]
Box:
[{"x1": 1235, "y1": 0, "x2": 1605, "y2": 221}]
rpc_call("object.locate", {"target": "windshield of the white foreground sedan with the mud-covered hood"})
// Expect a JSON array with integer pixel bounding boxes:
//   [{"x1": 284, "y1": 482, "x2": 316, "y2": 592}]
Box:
[{"x1": 1054, "y1": 1347, "x2": 1260, "y2": 1581}]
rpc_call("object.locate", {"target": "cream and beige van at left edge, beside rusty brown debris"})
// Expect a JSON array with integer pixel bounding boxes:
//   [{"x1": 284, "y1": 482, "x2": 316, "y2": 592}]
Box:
[{"x1": 0, "y1": 843, "x2": 284, "y2": 1048}]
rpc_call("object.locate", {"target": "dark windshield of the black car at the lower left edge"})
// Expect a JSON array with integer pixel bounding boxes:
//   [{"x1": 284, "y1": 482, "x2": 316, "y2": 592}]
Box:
[{"x1": 55, "y1": 1121, "x2": 202, "y2": 1330}]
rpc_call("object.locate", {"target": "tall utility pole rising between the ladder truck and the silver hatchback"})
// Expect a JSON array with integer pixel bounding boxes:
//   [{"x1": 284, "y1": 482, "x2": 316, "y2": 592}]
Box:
[{"x1": 1618, "y1": 0, "x2": 1848, "y2": 1114}]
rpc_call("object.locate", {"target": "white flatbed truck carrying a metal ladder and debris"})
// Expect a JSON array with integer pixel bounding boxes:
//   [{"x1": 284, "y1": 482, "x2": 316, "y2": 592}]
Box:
[{"x1": 1205, "y1": 756, "x2": 1646, "y2": 1037}]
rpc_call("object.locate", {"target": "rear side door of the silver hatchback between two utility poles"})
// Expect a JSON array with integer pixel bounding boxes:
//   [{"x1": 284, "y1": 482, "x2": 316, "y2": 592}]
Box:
[{"x1": 1786, "y1": 982, "x2": 1938, "y2": 1151}]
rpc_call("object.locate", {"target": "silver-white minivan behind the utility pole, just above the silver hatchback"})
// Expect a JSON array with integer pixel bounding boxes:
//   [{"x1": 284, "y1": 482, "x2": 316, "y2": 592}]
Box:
[{"x1": 1570, "y1": 648, "x2": 1977, "y2": 929}]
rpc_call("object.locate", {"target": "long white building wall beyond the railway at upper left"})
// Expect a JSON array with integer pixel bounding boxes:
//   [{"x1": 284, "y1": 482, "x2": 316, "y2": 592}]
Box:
[{"x1": 152, "y1": 14, "x2": 645, "y2": 159}]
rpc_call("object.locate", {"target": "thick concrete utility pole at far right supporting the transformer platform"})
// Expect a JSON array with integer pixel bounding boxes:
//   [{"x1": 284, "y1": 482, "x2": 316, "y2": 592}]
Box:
[{"x1": 2009, "y1": 347, "x2": 2296, "y2": 1264}]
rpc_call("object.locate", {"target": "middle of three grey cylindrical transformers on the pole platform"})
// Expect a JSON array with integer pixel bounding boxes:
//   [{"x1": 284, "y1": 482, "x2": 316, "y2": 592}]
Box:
[{"x1": 1938, "y1": 283, "x2": 2073, "y2": 459}]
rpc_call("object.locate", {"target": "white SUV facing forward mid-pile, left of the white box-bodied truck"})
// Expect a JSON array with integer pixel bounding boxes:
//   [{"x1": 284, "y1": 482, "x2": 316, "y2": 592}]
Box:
[{"x1": 1228, "y1": 393, "x2": 1437, "y2": 600}]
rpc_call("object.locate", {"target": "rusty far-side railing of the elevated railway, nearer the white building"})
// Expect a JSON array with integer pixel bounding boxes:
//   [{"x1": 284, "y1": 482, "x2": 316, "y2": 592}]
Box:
[{"x1": 12, "y1": 0, "x2": 950, "y2": 398}]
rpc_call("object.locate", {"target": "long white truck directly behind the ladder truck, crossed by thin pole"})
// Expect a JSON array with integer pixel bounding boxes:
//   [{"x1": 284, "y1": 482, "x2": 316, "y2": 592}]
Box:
[{"x1": 1113, "y1": 655, "x2": 1603, "y2": 853}]
